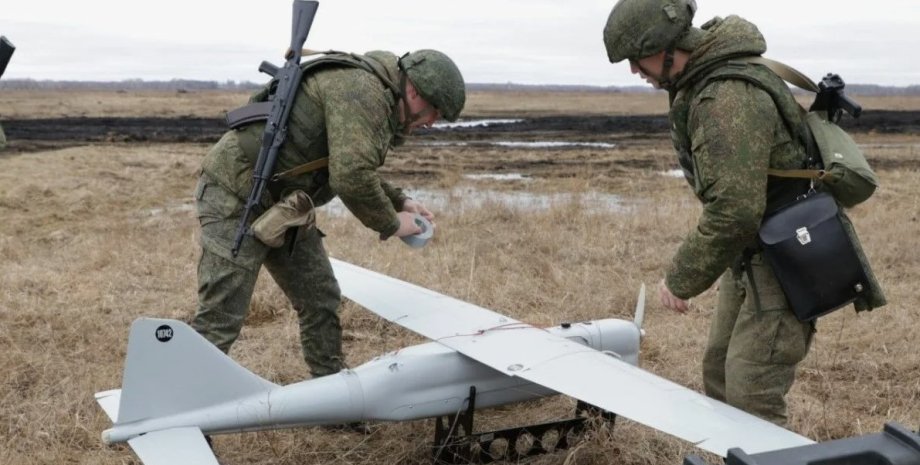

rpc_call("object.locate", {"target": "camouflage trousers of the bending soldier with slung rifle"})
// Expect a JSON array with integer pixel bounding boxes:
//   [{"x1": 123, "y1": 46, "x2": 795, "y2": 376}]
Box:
[{"x1": 192, "y1": 175, "x2": 343, "y2": 377}]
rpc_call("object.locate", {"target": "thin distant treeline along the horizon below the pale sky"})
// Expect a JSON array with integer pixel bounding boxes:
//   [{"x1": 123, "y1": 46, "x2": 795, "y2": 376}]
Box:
[{"x1": 0, "y1": 79, "x2": 920, "y2": 96}]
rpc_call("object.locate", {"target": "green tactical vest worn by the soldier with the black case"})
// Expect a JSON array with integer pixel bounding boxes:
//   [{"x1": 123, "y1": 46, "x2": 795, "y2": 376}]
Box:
[{"x1": 670, "y1": 59, "x2": 815, "y2": 213}]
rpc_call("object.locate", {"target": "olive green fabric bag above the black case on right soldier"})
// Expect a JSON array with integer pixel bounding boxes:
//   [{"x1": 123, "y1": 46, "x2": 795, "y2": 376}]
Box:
[{"x1": 805, "y1": 111, "x2": 878, "y2": 208}]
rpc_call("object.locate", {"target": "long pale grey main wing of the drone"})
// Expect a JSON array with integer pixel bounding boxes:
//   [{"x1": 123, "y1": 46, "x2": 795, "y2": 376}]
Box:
[{"x1": 332, "y1": 259, "x2": 813, "y2": 457}]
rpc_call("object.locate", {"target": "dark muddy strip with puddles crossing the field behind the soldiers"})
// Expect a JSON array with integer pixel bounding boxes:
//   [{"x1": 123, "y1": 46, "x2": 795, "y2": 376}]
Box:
[{"x1": 0, "y1": 110, "x2": 920, "y2": 179}]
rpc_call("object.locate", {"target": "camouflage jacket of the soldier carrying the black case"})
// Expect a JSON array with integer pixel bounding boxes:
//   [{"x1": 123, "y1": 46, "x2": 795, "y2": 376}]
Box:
[{"x1": 665, "y1": 16, "x2": 807, "y2": 299}]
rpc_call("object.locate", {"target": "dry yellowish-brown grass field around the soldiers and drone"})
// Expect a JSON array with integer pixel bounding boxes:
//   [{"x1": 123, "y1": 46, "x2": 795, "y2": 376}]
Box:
[{"x1": 0, "y1": 88, "x2": 920, "y2": 465}]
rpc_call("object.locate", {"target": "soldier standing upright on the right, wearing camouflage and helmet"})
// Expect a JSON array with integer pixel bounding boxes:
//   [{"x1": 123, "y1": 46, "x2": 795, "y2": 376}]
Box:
[{"x1": 604, "y1": 0, "x2": 884, "y2": 425}]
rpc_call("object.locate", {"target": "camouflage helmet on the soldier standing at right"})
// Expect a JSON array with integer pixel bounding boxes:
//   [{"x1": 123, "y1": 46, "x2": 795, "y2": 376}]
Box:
[{"x1": 604, "y1": 0, "x2": 696, "y2": 63}]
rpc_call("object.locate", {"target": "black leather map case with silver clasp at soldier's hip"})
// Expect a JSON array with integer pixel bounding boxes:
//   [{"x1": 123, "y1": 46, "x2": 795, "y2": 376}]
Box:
[{"x1": 759, "y1": 192, "x2": 868, "y2": 321}]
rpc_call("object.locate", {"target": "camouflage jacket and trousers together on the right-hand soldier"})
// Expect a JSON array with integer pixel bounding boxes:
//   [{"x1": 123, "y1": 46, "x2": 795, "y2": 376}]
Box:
[{"x1": 665, "y1": 16, "x2": 811, "y2": 424}]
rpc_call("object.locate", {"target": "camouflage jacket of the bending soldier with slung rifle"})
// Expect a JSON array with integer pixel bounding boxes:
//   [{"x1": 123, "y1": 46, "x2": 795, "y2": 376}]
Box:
[{"x1": 202, "y1": 51, "x2": 406, "y2": 237}]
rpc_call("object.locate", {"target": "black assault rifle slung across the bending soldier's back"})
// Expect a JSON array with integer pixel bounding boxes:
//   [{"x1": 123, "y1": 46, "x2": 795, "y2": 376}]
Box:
[{"x1": 228, "y1": 0, "x2": 319, "y2": 257}]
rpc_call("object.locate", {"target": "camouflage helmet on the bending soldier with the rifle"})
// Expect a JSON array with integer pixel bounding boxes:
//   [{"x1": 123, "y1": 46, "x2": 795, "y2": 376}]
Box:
[{"x1": 399, "y1": 50, "x2": 466, "y2": 121}]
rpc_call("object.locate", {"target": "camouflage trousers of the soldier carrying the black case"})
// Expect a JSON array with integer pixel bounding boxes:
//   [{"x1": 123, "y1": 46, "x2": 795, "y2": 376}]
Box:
[{"x1": 703, "y1": 254, "x2": 814, "y2": 426}]
